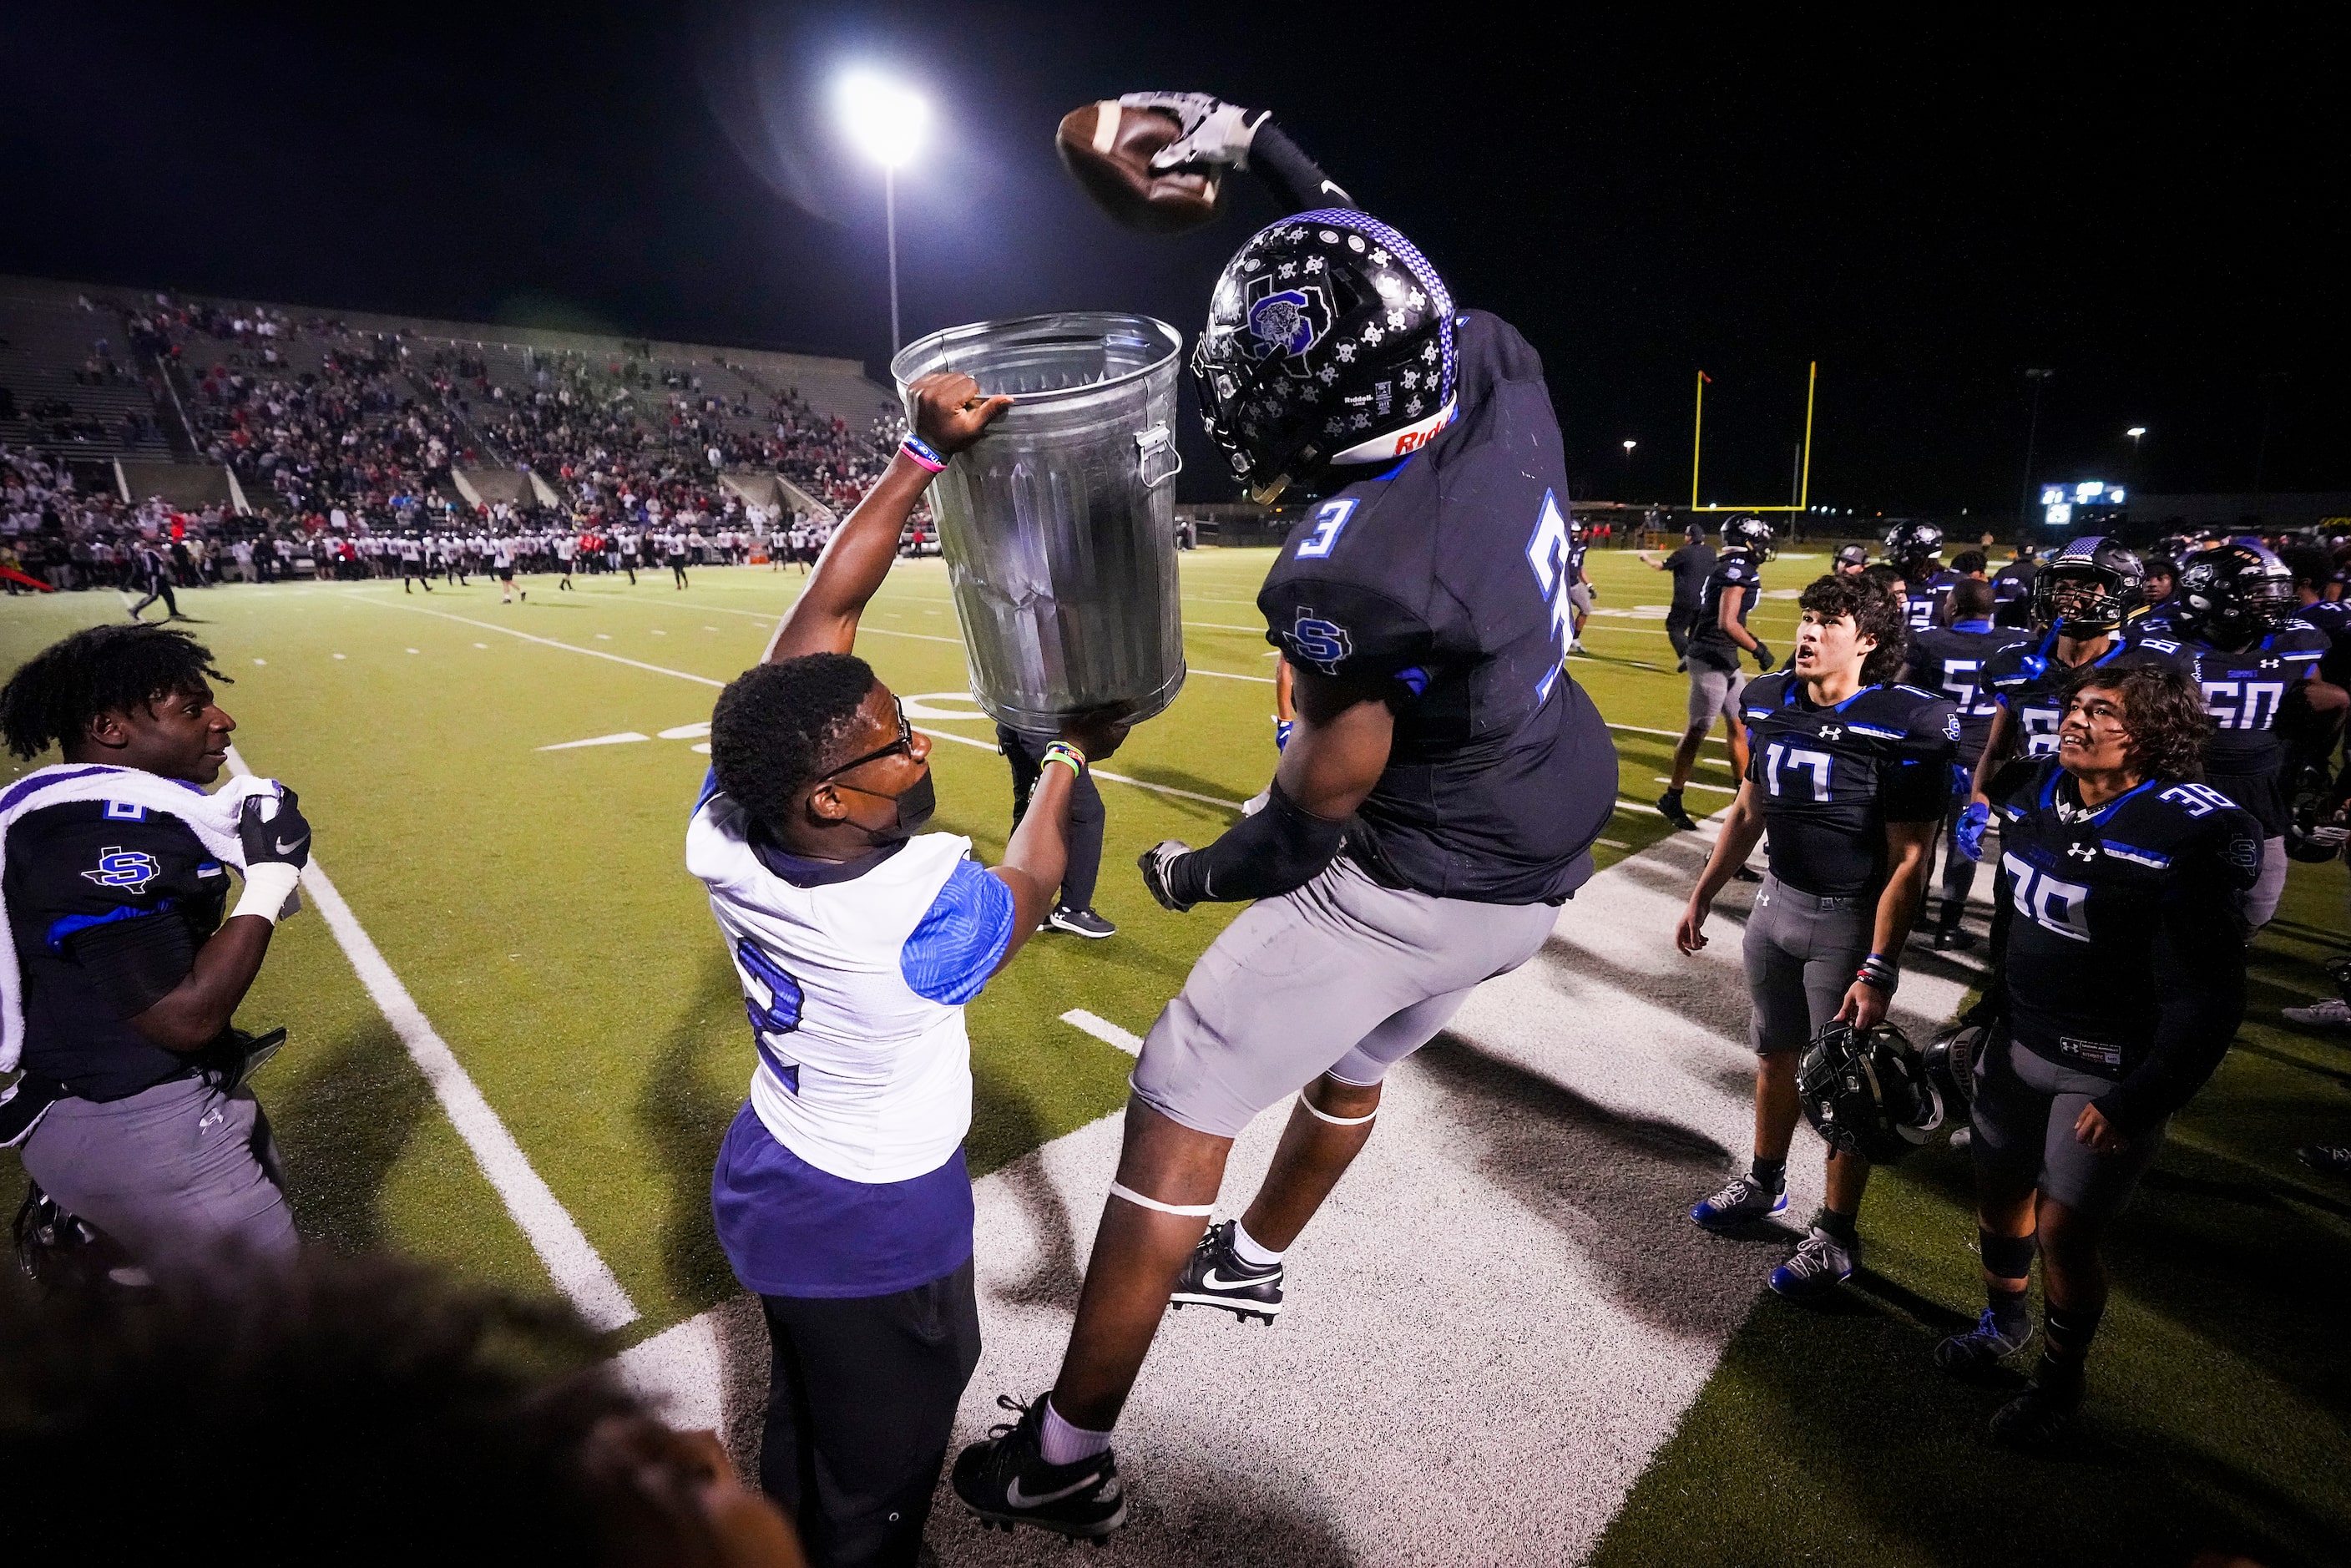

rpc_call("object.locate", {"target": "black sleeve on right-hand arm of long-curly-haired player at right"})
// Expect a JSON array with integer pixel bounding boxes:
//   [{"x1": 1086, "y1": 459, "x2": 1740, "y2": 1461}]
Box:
[{"x1": 2097, "y1": 811, "x2": 2262, "y2": 1138}]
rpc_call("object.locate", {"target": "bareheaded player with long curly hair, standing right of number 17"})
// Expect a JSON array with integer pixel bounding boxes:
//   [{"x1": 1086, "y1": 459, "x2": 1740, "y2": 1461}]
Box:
[{"x1": 1935, "y1": 665, "x2": 2262, "y2": 1448}]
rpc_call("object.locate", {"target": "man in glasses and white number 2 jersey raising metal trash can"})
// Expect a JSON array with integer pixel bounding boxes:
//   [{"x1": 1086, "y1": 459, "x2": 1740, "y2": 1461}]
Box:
[{"x1": 686, "y1": 374, "x2": 1124, "y2": 1563}]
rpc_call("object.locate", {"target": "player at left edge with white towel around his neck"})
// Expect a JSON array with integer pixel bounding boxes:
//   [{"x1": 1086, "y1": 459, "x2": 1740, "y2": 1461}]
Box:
[{"x1": 0, "y1": 625, "x2": 311, "y2": 1283}]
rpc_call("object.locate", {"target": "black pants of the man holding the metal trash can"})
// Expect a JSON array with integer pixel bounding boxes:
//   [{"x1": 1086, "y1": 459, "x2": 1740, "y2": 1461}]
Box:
[{"x1": 760, "y1": 1257, "x2": 980, "y2": 1568}]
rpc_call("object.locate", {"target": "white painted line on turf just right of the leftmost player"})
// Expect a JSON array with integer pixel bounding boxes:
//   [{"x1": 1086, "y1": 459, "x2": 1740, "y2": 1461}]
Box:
[{"x1": 228, "y1": 747, "x2": 637, "y2": 1331}]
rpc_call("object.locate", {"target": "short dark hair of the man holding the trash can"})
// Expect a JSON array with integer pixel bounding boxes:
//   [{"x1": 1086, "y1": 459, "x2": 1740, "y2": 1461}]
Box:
[{"x1": 710, "y1": 654, "x2": 875, "y2": 827}]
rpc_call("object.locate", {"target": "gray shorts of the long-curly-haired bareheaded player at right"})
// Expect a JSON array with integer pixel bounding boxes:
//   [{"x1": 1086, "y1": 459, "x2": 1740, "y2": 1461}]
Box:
[{"x1": 1970, "y1": 1041, "x2": 2170, "y2": 1220}]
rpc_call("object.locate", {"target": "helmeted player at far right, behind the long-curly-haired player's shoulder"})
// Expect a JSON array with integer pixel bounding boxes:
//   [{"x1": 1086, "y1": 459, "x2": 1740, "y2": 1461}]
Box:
[{"x1": 2130, "y1": 541, "x2": 2351, "y2": 933}]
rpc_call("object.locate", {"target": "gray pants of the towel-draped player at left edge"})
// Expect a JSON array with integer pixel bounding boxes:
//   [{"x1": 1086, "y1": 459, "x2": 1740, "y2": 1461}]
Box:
[{"x1": 23, "y1": 1079, "x2": 296, "y2": 1272}]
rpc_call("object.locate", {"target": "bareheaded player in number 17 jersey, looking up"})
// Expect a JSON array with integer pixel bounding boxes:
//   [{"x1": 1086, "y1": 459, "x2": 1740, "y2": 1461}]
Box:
[{"x1": 1674, "y1": 576, "x2": 1959, "y2": 1297}]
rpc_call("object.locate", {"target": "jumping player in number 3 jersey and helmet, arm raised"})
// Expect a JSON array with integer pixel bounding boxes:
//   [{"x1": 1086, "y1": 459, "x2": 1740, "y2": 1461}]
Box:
[{"x1": 954, "y1": 99, "x2": 1617, "y2": 1535}]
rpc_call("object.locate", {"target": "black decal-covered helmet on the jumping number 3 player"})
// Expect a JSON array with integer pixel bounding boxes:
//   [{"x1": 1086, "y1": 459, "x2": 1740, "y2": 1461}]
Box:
[{"x1": 1192, "y1": 207, "x2": 1458, "y2": 503}]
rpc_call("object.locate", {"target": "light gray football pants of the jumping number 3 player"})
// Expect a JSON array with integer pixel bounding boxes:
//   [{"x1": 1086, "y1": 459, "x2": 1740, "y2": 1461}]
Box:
[{"x1": 1133, "y1": 858, "x2": 1559, "y2": 1138}]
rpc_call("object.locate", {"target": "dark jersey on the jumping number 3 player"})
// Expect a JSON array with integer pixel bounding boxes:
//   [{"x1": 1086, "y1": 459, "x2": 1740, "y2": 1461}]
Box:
[{"x1": 1258, "y1": 311, "x2": 1617, "y2": 903}]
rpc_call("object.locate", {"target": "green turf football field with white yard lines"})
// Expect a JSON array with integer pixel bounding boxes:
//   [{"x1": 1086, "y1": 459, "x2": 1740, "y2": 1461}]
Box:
[{"x1": 0, "y1": 550, "x2": 2351, "y2": 1563}]
